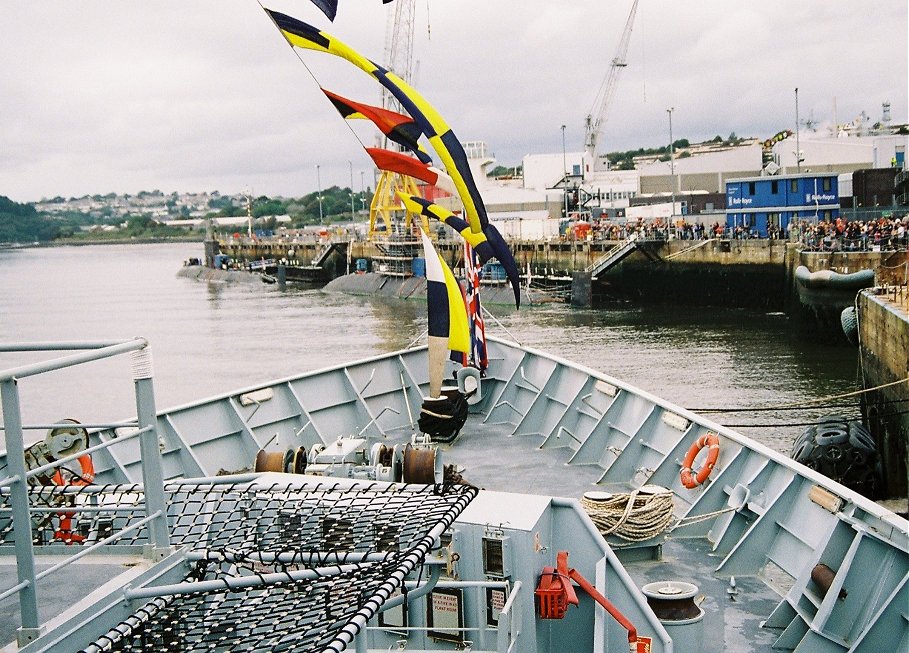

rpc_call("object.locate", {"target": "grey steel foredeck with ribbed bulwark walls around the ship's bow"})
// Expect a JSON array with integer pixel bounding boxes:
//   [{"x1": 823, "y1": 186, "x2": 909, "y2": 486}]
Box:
[{"x1": 3, "y1": 339, "x2": 909, "y2": 653}]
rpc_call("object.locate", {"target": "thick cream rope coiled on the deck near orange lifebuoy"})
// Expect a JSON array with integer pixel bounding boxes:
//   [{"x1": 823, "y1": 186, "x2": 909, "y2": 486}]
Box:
[{"x1": 581, "y1": 488, "x2": 673, "y2": 542}]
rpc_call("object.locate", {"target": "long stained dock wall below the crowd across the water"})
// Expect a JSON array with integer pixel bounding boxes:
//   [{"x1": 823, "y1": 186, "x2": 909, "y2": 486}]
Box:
[{"x1": 218, "y1": 238, "x2": 906, "y2": 314}]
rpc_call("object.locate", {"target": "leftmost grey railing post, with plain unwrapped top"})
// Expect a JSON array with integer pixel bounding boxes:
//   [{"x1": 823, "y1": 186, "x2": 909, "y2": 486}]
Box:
[{"x1": 0, "y1": 379, "x2": 41, "y2": 647}]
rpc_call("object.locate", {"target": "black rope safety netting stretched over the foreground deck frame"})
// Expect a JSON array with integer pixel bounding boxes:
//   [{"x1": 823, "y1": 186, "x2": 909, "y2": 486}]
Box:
[{"x1": 8, "y1": 480, "x2": 477, "y2": 653}]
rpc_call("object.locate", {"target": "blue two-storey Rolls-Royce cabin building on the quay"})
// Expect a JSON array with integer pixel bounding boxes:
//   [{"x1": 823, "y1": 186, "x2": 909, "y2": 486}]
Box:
[{"x1": 726, "y1": 173, "x2": 840, "y2": 238}]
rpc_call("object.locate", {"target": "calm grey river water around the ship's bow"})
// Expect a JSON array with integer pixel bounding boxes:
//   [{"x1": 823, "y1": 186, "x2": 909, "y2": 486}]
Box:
[{"x1": 0, "y1": 243, "x2": 857, "y2": 453}]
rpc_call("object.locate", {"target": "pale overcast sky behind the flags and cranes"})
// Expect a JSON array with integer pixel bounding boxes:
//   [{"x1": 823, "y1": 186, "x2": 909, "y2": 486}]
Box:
[{"x1": 0, "y1": 0, "x2": 909, "y2": 202}]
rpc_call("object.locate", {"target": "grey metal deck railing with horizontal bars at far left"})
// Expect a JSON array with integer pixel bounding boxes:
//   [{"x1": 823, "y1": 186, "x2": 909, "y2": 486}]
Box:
[{"x1": 0, "y1": 338, "x2": 170, "y2": 647}]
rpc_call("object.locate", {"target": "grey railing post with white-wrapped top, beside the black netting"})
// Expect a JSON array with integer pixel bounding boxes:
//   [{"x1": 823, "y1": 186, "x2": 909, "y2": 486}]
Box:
[{"x1": 130, "y1": 346, "x2": 170, "y2": 556}]
